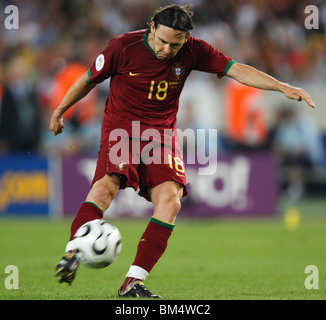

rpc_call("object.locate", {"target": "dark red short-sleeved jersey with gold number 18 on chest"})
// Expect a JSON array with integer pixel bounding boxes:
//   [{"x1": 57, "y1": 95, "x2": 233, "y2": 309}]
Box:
[{"x1": 87, "y1": 30, "x2": 234, "y2": 139}]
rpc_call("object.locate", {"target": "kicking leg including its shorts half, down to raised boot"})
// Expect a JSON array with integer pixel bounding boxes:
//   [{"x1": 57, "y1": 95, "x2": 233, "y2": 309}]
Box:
[{"x1": 56, "y1": 131, "x2": 138, "y2": 284}]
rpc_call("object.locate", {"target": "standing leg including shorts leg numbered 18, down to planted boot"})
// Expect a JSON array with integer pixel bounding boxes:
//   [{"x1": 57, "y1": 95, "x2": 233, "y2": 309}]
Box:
[{"x1": 119, "y1": 136, "x2": 187, "y2": 297}]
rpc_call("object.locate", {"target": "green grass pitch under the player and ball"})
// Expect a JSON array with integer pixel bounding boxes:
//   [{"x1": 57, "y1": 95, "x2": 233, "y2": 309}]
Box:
[{"x1": 0, "y1": 203, "x2": 326, "y2": 300}]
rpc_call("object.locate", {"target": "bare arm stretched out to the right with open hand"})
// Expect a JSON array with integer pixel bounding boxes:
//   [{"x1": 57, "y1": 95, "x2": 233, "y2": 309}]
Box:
[{"x1": 227, "y1": 62, "x2": 316, "y2": 108}]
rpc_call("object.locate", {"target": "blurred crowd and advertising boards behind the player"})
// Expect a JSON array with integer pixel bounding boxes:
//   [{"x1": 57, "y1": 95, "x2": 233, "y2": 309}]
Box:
[{"x1": 0, "y1": 0, "x2": 326, "y2": 220}]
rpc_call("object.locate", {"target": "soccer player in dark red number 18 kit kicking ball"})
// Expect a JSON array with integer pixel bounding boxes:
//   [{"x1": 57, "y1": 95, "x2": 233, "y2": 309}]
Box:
[{"x1": 50, "y1": 5, "x2": 315, "y2": 298}]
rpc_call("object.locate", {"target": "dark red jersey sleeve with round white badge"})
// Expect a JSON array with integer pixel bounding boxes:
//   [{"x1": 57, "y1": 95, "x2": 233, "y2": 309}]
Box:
[{"x1": 86, "y1": 38, "x2": 121, "y2": 83}]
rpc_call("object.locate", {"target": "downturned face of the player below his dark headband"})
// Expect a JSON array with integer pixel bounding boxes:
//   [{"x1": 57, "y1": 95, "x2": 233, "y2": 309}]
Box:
[{"x1": 150, "y1": 23, "x2": 189, "y2": 60}]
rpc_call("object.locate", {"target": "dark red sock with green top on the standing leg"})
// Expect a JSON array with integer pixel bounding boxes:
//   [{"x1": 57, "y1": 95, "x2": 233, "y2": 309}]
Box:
[{"x1": 121, "y1": 218, "x2": 174, "y2": 291}]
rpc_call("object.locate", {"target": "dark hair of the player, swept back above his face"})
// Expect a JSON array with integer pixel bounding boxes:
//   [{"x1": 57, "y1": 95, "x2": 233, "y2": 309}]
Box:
[{"x1": 151, "y1": 4, "x2": 193, "y2": 33}]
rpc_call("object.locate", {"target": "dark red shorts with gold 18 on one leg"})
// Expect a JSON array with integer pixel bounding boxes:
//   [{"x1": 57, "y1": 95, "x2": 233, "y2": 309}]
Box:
[{"x1": 92, "y1": 129, "x2": 187, "y2": 201}]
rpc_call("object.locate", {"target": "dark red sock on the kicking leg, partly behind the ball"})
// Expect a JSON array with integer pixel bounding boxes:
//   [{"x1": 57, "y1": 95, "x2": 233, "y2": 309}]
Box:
[{"x1": 70, "y1": 202, "x2": 103, "y2": 240}]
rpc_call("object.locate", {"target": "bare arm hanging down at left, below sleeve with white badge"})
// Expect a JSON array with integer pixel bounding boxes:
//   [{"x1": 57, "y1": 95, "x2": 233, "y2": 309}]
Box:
[{"x1": 49, "y1": 72, "x2": 96, "y2": 136}]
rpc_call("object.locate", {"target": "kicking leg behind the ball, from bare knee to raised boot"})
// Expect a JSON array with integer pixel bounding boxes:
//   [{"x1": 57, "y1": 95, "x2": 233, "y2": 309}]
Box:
[{"x1": 56, "y1": 174, "x2": 120, "y2": 285}]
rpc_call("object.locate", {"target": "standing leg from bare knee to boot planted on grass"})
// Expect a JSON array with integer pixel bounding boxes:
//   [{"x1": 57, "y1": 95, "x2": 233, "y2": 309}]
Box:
[{"x1": 119, "y1": 181, "x2": 184, "y2": 298}]
